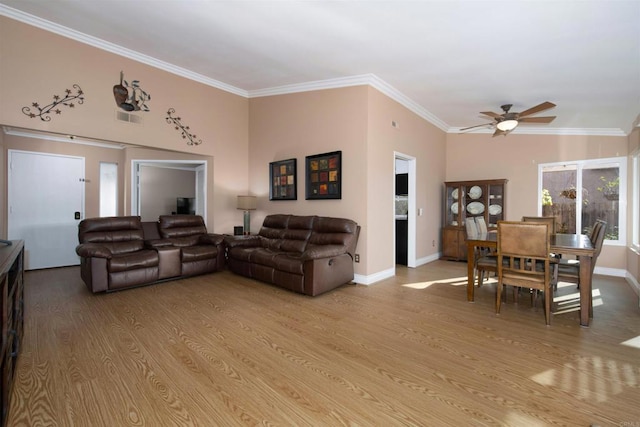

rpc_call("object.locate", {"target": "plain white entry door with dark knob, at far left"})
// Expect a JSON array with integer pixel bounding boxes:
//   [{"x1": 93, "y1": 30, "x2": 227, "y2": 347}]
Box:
[{"x1": 7, "y1": 150, "x2": 84, "y2": 270}]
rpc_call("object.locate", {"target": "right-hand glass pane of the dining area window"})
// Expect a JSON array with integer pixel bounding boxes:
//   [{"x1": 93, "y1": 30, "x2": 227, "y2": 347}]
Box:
[{"x1": 582, "y1": 164, "x2": 620, "y2": 240}]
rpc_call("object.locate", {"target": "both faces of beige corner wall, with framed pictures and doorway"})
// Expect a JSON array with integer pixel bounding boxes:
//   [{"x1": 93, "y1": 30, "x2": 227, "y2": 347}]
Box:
[{"x1": 249, "y1": 86, "x2": 445, "y2": 275}]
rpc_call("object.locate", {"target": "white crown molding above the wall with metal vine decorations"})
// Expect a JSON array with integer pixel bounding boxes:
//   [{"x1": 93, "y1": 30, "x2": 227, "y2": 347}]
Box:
[{"x1": 0, "y1": 4, "x2": 247, "y2": 98}]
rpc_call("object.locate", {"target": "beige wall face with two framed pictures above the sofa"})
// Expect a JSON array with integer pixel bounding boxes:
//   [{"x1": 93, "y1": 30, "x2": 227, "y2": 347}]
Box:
[{"x1": 249, "y1": 86, "x2": 370, "y2": 274}]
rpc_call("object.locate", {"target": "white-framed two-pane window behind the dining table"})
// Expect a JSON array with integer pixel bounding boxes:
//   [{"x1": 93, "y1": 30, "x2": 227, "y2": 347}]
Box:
[{"x1": 538, "y1": 157, "x2": 626, "y2": 245}]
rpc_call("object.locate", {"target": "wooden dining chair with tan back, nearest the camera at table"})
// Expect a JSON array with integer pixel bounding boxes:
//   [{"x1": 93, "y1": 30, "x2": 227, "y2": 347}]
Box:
[{"x1": 496, "y1": 221, "x2": 553, "y2": 325}]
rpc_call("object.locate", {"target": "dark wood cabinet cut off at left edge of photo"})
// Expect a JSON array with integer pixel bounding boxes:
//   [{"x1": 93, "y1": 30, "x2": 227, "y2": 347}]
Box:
[{"x1": 0, "y1": 240, "x2": 24, "y2": 426}]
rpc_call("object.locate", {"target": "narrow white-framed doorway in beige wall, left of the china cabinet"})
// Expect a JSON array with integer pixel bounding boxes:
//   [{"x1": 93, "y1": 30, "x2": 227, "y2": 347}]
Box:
[{"x1": 393, "y1": 152, "x2": 416, "y2": 267}]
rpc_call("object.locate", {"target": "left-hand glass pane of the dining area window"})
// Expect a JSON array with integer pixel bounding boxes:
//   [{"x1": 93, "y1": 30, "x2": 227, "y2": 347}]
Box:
[{"x1": 542, "y1": 165, "x2": 578, "y2": 233}]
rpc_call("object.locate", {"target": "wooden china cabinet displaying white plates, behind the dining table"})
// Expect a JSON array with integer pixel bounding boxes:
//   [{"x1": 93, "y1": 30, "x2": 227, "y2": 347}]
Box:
[{"x1": 442, "y1": 179, "x2": 507, "y2": 261}]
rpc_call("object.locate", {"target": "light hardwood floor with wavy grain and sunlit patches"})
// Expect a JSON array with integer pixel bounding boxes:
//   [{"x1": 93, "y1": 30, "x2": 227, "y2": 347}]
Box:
[{"x1": 8, "y1": 261, "x2": 640, "y2": 427}]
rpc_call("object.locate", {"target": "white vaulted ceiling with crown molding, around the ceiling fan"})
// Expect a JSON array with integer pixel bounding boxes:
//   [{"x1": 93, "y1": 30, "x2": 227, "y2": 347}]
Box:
[{"x1": 0, "y1": 0, "x2": 640, "y2": 135}]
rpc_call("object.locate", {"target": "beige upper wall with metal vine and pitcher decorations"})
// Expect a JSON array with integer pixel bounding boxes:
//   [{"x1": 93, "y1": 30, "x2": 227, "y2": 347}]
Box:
[{"x1": 0, "y1": 16, "x2": 249, "y2": 232}]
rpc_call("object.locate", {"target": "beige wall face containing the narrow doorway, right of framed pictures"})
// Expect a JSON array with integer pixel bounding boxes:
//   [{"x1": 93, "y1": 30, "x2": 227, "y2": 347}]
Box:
[{"x1": 366, "y1": 88, "x2": 446, "y2": 272}]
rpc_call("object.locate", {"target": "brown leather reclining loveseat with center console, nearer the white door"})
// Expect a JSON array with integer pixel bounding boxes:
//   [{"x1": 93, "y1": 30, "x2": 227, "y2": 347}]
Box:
[{"x1": 76, "y1": 215, "x2": 225, "y2": 292}]
